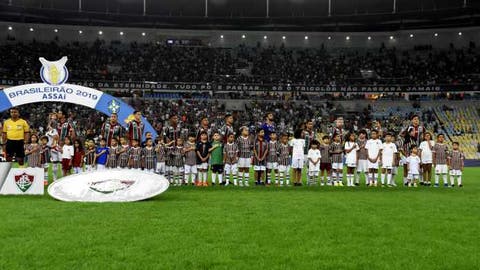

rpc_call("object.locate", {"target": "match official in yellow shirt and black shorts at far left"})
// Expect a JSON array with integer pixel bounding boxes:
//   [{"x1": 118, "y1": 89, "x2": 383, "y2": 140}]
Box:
[{"x1": 2, "y1": 108, "x2": 30, "y2": 166}]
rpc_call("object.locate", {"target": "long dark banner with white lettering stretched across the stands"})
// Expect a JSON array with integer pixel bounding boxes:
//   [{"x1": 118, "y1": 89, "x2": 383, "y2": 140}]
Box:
[{"x1": 0, "y1": 79, "x2": 480, "y2": 93}]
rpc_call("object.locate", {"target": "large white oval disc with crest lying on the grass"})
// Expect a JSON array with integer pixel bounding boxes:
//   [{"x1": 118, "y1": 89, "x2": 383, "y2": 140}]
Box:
[{"x1": 48, "y1": 169, "x2": 169, "y2": 202}]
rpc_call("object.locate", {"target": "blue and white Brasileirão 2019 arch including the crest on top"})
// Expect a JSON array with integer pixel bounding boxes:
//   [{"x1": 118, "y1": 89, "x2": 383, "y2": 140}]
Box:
[{"x1": 0, "y1": 57, "x2": 157, "y2": 137}]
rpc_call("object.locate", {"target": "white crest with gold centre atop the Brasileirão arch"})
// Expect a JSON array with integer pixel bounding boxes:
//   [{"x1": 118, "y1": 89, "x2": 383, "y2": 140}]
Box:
[{"x1": 38, "y1": 56, "x2": 68, "y2": 86}]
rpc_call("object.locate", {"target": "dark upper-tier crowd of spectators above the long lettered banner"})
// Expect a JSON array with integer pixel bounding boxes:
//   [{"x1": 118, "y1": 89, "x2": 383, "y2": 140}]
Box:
[{"x1": 0, "y1": 40, "x2": 480, "y2": 85}]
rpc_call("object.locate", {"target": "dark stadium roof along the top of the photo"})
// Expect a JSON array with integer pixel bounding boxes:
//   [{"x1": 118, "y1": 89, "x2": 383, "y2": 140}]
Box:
[{"x1": 0, "y1": 0, "x2": 480, "y2": 31}]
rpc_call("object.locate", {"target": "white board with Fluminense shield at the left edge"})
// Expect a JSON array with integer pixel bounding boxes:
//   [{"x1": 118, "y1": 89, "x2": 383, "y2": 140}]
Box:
[{"x1": 0, "y1": 162, "x2": 44, "y2": 195}]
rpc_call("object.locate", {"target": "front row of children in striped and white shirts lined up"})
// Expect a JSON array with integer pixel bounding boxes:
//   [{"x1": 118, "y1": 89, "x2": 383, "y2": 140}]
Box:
[{"x1": 19, "y1": 127, "x2": 464, "y2": 187}]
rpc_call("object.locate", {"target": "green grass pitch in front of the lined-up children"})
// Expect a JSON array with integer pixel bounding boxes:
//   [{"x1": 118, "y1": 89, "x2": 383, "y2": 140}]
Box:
[{"x1": 0, "y1": 168, "x2": 480, "y2": 270}]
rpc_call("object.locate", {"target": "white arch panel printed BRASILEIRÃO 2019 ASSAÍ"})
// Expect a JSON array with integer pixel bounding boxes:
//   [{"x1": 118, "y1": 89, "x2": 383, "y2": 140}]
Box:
[{"x1": 4, "y1": 83, "x2": 103, "y2": 108}]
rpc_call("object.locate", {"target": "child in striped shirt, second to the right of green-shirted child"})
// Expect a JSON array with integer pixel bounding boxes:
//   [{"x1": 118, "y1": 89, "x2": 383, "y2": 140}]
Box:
[{"x1": 237, "y1": 126, "x2": 253, "y2": 186}]
